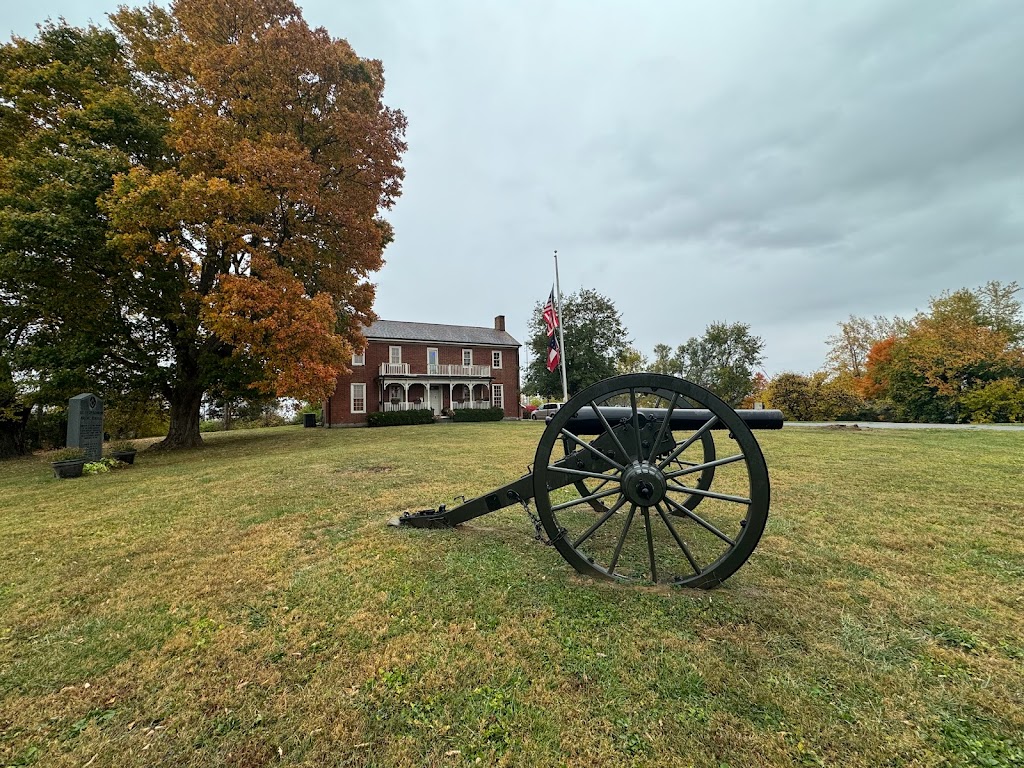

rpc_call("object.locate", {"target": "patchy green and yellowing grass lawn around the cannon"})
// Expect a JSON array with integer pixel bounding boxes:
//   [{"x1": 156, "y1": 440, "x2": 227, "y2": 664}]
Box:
[{"x1": 0, "y1": 423, "x2": 1024, "y2": 768}]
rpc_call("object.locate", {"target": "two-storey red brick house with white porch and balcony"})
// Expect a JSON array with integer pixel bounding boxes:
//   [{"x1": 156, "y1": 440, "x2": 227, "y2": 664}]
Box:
[{"x1": 324, "y1": 314, "x2": 521, "y2": 427}]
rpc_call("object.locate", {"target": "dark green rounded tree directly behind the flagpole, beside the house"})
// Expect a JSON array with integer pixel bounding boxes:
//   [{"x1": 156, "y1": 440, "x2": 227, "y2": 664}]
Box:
[{"x1": 524, "y1": 289, "x2": 630, "y2": 399}]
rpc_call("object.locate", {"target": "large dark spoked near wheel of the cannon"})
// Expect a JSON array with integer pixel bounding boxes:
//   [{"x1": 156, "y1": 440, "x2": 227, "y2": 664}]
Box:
[{"x1": 532, "y1": 374, "x2": 770, "y2": 589}]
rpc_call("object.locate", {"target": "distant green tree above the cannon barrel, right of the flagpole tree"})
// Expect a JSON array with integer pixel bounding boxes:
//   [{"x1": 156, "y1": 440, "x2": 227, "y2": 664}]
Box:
[{"x1": 654, "y1": 323, "x2": 764, "y2": 407}]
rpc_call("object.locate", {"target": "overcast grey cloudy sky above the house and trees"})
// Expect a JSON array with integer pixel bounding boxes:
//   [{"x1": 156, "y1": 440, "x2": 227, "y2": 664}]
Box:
[{"x1": 8, "y1": 0, "x2": 1024, "y2": 375}]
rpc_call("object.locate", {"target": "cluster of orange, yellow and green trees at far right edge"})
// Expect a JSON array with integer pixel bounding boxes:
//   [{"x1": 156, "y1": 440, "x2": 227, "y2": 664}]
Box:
[{"x1": 760, "y1": 281, "x2": 1024, "y2": 423}]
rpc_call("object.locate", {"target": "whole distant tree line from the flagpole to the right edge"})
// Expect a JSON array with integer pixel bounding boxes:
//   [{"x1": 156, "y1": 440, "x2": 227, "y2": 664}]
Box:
[{"x1": 525, "y1": 281, "x2": 1024, "y2": 422}]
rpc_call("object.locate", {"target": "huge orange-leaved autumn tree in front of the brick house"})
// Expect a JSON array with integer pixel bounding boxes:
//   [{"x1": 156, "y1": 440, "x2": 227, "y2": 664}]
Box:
[{"x1": 0, "y1": 0, "x2": 406, "y2": 446}]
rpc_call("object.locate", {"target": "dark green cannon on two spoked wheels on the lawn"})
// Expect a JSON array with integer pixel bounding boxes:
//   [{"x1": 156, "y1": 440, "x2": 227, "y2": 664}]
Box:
[{"x1": 391, "y1": 373, "x2": 783, "y2": 589}]
